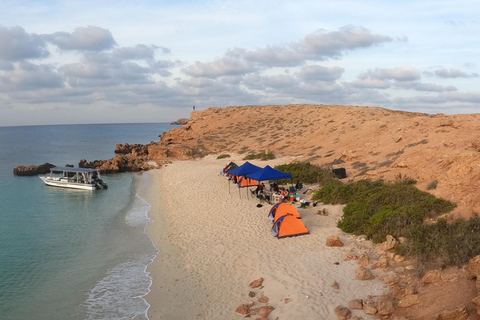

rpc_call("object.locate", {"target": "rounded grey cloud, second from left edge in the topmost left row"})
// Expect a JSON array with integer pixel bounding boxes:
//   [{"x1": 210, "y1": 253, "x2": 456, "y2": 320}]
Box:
[{"x1": 44, "y1": 26, "x2": 116, "y2": 51}]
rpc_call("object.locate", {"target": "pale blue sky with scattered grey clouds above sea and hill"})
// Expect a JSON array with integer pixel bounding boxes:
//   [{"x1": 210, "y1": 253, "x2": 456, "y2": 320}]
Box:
[{"x1": 0, "y1": 0, "x2": 480, "y2": 126}]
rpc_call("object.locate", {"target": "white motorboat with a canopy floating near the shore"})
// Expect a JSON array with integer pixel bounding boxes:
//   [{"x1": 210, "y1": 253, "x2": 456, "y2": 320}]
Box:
[{"x1": 40, "y1": 167, "x2": 108, "y2": 190}]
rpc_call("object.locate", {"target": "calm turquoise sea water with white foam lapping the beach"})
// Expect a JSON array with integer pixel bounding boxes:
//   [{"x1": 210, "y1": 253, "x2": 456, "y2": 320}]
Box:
[{"x1": 0, "y1": 123, "x2": 173, "y2": 320}]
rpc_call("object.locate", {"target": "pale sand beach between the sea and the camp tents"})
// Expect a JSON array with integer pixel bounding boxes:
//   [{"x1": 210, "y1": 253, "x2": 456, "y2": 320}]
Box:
[{"x1": 138, "y1": 156, "x2": 388, "y2": 320}]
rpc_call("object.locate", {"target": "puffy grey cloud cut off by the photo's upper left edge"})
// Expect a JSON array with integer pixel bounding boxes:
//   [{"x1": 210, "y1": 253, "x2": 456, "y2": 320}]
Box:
[{"x1": 0, "y1": 26, "x2": 49, "y2": 62}]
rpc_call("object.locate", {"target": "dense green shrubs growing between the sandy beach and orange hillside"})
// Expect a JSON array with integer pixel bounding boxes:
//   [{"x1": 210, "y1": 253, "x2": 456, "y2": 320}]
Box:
[{"x1": 275, "y1": 162, "x2": 480, "y2": 272}]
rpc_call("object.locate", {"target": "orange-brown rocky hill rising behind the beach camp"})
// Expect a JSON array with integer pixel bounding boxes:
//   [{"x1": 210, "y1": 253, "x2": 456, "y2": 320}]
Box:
[{"x1": 149, "y1": 105, "x2": 480, "y2": 217}]
